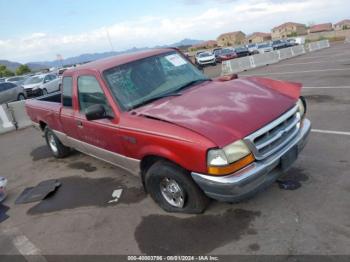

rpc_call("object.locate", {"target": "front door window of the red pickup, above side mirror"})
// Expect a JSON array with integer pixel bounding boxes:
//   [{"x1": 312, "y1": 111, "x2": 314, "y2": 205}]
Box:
[{"x1": 78, "y1": 76, "x2": 112, "y2": 113}]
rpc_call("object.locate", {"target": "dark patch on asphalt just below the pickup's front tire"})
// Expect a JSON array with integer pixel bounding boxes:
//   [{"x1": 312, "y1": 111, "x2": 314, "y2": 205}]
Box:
[{"x1": 135, "y1": 209, "x2": 261, "y2": 255}]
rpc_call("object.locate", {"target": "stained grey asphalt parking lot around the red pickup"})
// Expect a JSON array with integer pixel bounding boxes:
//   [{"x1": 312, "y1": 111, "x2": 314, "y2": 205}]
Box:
[{"x1": 0, "y1": 44, "x2": 350, "y2": 255}]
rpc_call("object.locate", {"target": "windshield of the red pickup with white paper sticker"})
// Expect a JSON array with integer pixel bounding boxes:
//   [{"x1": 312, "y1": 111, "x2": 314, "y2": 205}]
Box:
[{"x1": 104, "y1": 51, "x2": 209, "y2": 110}]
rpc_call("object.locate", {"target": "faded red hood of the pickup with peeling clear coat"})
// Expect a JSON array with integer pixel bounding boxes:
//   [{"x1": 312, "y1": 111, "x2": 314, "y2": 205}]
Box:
[{"x1": 135, "y1": 77, "x2": 301, "y2": 147}]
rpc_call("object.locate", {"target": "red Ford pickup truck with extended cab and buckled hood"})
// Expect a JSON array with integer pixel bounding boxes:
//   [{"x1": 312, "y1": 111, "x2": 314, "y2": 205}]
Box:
[{"x1": 26, "y1": 49, "x2": 311, "y2": 213}]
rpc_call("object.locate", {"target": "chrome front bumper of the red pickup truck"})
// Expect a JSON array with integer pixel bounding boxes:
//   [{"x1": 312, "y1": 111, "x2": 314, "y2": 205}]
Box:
[{"x1": 191, "y1": 119, "x2": 311, "y2": 202}]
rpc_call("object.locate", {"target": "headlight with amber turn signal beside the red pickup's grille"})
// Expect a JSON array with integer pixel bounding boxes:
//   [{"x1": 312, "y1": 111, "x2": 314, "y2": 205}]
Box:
[{"x1": 207, "y1": 140, "x2": 255, "y2": 175}]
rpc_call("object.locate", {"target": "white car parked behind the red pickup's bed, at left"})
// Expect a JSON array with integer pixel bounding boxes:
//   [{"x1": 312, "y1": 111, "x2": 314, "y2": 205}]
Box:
[{"x1": 23, "y1": 74, "x2": 62, "y2": 97}]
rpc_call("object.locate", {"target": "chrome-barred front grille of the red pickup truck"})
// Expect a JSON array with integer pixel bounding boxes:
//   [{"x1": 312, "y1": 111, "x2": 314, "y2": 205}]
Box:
[{"x1": 244, "y1": 106, "x2": 301, "y2": 160}]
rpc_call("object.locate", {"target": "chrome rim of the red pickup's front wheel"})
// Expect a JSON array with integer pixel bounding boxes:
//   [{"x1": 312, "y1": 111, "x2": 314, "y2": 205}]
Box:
[{"x1": 160, "y1": 177, "x2": 185, "y2": 208}]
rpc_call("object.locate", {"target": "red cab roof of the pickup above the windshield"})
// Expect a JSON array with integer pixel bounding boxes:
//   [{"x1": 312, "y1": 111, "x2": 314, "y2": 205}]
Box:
[{"x1": 63, "y1": 48, "x2": 175, "y2": 76}]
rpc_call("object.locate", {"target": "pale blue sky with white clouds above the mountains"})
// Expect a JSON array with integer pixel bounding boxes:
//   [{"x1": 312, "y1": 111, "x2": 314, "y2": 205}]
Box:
[{"x1": 0, "y1": 0, "x2": 350, "y2": 62}]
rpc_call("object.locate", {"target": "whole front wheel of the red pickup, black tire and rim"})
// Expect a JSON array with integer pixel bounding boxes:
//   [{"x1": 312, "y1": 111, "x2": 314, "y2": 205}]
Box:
[{"x1": 145, "y1": 160, "x2": 209, "y2": 214}]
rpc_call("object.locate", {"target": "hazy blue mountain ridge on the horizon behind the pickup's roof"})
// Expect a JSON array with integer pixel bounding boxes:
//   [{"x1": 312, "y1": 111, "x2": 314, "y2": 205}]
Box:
[{"x1": 28, "y1": 39, "x2": 203, "y2": 68}]
